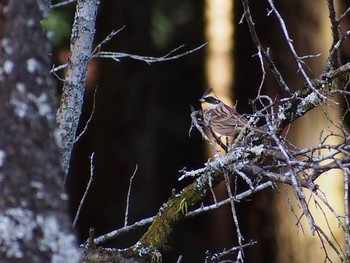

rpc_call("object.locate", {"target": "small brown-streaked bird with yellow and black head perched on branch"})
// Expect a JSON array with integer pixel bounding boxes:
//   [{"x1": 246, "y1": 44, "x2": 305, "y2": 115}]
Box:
[{"x1": 199, "y1": 89, "x2": 254, "y2": 136}]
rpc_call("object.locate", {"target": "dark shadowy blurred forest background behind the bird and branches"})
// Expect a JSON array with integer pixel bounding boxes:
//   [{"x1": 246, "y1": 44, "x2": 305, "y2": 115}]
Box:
[{"x1": 47, "y1": 0, "x2": 349, "y2": 263}]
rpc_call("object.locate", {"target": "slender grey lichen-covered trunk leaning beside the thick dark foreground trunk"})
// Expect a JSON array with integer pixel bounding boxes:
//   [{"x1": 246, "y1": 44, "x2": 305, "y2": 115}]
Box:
[{"x1": 57, "y1": 0, "x2": 99, "y2": 175}]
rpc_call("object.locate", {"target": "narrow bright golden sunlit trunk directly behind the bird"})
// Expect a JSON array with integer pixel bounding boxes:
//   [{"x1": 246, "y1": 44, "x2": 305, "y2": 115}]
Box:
[{"x1": 205, "y1": 0, "x2": 235, "y2": 252}]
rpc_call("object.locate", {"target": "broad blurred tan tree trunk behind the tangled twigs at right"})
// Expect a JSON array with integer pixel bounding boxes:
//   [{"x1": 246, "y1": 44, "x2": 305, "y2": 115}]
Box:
[{"x1": 270, "y1": 0, "x2": 343, "y2": 263}]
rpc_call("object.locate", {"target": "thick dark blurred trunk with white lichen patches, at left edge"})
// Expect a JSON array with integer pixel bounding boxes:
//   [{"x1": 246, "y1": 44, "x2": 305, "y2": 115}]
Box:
[{"x1": 0, "y1": 0, "x2": 79, "y2": 263}]
